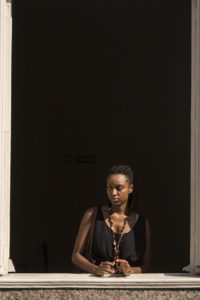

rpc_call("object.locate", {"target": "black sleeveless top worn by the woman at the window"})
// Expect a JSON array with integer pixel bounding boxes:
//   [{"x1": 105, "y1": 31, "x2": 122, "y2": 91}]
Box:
[{"x1": 92, "y1": 207, "x2": 146, "y2": 267}]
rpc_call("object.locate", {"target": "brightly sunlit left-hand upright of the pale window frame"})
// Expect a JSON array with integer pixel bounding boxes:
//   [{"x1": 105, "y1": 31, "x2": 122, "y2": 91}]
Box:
[{"x1": 0, "y1": 0, "x2": 12, "y2": 274}]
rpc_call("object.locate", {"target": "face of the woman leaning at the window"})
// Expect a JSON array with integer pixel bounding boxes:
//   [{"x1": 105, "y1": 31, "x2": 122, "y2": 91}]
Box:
[{"x1": 107, "y1": 174, "x2": 133, "y2": 205}]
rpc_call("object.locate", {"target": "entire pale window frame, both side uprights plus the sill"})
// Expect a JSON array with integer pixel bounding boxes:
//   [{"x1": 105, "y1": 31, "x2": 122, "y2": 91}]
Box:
[{"x1": 0, "y1": 0, "x2": 200, "y2": 288}]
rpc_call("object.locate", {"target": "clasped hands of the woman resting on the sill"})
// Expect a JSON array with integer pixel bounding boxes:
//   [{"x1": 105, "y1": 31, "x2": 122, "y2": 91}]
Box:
[{"x1": 95, "y1": 259, "x2": 135, "y2": 276}]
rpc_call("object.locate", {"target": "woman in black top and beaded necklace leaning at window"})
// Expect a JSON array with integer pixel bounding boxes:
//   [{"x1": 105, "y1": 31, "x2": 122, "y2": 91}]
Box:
[{"x1": 72, "y1": 165, "x2": 151, "y2": 276}]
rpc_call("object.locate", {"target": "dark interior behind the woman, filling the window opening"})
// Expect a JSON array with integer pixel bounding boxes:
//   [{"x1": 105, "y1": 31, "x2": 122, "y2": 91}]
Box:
[{"x1": 11, "y1": 0, "x2": 191, "y2": 272}]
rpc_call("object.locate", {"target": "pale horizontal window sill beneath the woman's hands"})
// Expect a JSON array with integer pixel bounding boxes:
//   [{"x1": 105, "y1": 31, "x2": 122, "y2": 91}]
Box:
[{"x1": 0, "y1": 273, "x2": 200, "y2": 289}]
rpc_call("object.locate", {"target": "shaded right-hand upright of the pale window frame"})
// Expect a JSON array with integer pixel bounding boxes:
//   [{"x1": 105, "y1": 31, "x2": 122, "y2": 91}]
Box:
[{"x1": 184, "y1": 0, "x2": 200, "y2": 273}]
